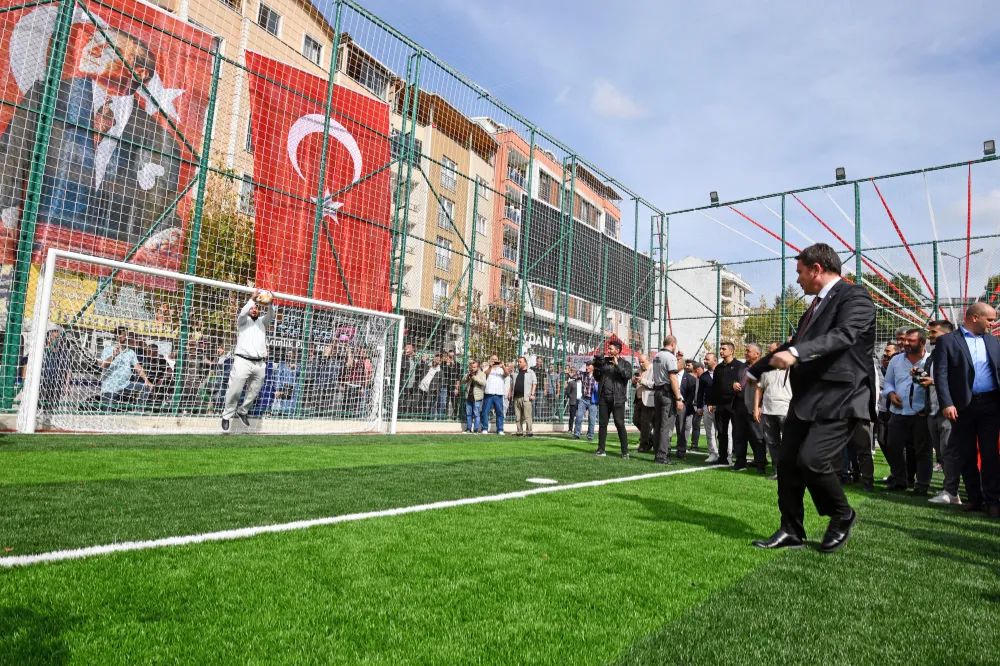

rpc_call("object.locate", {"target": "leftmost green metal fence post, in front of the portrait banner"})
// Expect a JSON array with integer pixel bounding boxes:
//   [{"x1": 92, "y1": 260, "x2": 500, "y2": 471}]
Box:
[{"x1": 0, "y1": 0, "x2": 76, "y2": 409}]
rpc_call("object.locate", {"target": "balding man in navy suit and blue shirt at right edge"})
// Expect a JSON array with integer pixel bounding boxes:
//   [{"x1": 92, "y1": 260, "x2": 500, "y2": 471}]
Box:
[{"x1": 933, "y1": 303, "x2": 1000, "y2": 518}]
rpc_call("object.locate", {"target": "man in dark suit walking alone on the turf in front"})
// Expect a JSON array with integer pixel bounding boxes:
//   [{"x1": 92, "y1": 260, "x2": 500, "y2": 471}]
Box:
[{"x1": 749, "y1": 243, "x2": 876, "y2": 553}]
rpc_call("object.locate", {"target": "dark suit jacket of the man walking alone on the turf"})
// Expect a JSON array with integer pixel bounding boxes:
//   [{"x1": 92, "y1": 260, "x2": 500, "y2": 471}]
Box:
[{"x1": 750, "y1": 280, "x2": 878, "y2": 421}]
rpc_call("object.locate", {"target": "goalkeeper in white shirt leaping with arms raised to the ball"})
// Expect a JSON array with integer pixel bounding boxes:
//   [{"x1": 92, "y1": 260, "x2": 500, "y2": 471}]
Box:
[{"x1": 222, "y1": 289, "x2": 274, "y2": 432}]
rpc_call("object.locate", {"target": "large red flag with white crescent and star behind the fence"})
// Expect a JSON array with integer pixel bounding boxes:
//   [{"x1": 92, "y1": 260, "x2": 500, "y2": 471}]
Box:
[{"x1": 246, "y1": 51, "x2": 392, "y2": 311}]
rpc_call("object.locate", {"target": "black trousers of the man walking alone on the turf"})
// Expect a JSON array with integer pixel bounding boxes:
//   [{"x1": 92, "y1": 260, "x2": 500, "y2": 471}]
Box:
[{"x1": 778, "y1": 412, "x2": 858, "y2": 539}]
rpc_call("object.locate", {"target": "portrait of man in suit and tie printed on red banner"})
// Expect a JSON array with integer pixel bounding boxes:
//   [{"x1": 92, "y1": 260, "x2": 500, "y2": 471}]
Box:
[{"x1": 0, "y1": 28, "x2": 181, "y2": 249}]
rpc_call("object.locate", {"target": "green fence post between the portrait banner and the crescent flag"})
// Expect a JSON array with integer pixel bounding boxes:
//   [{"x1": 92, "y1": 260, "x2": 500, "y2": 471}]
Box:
[{"x1": 171, "y1": 40, "x2": 222, "y2": 414}]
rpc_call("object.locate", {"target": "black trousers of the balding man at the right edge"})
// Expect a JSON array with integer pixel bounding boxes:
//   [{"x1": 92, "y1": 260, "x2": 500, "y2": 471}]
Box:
[{"x1": 951, "y1": 391, "x2": 1000, "y2": 506}]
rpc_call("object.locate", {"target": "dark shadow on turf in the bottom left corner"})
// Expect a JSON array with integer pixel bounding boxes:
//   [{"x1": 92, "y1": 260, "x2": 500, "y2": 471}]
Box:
[{"x1": 0, "y1": 606, "x2": 72, "y2": 664}]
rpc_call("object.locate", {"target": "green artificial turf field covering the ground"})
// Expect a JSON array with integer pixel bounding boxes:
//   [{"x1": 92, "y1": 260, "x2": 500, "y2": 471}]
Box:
[{"x1": 0, "y1": 428, "x2": 1000, "y2": 666}]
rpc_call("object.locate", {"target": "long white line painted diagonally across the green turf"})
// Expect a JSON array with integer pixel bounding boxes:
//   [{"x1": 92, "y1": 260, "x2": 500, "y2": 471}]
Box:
[{"x1": 0, "y1": 465, "x2": 724, "y2": 568}]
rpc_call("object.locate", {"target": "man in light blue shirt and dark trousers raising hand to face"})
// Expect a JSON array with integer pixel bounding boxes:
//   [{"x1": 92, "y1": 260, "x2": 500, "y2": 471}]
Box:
[{"x1": 882, "y1": 328, "x2": 934, "y2": 496}]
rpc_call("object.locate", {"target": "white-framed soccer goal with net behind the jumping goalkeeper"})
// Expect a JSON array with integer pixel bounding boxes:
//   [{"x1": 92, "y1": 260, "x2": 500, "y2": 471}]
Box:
[{"x1": 17, "y1": 249, "x2": 404, "y2": 434}]
